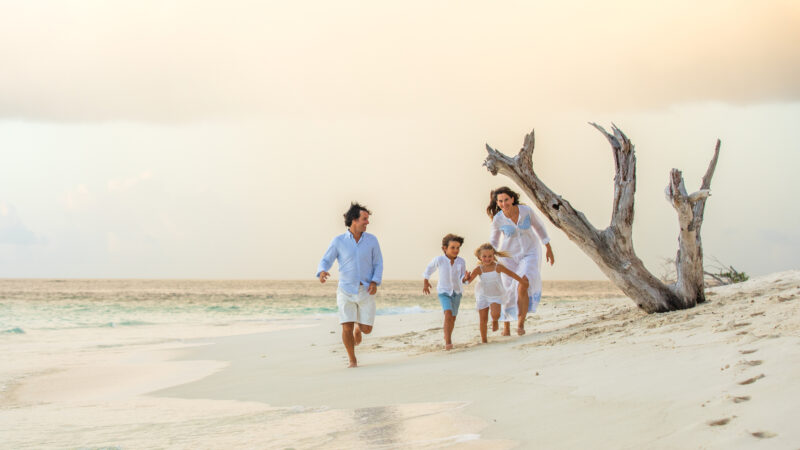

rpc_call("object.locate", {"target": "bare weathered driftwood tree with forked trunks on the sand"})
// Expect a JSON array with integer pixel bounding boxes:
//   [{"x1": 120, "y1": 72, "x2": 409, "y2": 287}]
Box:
[{"x1": 484, "y1": 123, "x2": 720, "y2": 313}]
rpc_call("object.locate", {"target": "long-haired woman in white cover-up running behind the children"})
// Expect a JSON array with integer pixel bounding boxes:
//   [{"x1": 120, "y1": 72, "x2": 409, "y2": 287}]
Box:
[{"x1": 486, "y1": 186, "x2": 555, "y2": 336}]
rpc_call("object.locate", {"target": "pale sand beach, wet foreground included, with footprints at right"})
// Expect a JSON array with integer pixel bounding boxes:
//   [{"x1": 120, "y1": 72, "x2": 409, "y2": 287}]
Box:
[{"x1": 0, "y1": 271, "x2": 800, "y2": 449}]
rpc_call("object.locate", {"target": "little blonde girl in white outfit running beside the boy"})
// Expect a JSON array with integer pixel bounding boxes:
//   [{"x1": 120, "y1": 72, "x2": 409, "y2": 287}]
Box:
[{"x1": 467, "y1": 243, "x2": 528, "y2": 343}]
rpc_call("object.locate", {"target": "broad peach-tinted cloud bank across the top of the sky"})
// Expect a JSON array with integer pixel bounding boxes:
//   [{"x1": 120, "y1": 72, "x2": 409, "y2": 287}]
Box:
[{"x1": 0, "y1": 0, "x2": 800, "y2": 122}]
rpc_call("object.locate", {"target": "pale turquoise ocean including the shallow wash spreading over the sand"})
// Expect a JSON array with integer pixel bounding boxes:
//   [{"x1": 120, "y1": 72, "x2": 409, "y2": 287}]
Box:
[{"x1": 0, "y1": 280, "x2": 619, "y2": 448}]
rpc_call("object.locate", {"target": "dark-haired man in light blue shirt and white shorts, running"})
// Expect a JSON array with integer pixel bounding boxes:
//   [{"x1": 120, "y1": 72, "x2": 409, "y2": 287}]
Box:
[{"x1": 317, "y1": 203, "x2": 383, "y2": 367}]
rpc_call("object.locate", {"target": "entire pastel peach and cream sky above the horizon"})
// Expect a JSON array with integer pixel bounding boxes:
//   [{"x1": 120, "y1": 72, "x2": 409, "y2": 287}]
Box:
[{"x1": 0, "y1": 0, "x2": 800, "y2": 279}]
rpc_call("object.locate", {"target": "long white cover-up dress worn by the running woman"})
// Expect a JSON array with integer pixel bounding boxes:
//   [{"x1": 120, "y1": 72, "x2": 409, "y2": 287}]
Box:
[{"x1": 489, "y1": 205, "x2": 550, "y2": 321}]
